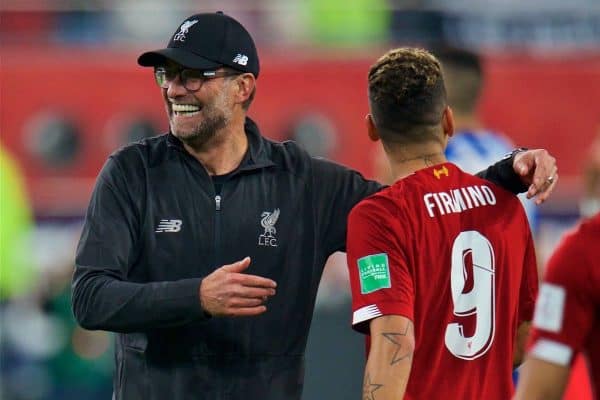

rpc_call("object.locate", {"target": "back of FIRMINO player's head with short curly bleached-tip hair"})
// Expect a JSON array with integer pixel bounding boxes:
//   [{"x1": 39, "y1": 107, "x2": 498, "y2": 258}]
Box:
[{"x1": 369, "y1": 47, "x2": 446, "y2": 143}]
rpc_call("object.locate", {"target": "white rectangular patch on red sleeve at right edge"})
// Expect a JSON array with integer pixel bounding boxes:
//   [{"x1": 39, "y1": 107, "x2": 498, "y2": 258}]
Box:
[{"x1": 533, "y1": 283, "x2": 566, "y2": 332}]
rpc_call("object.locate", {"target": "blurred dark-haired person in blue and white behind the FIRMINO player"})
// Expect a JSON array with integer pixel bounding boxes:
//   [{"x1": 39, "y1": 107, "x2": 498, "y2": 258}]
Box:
[{"x1": 434, "y1": 48, "x2": 538, "y2": 234}]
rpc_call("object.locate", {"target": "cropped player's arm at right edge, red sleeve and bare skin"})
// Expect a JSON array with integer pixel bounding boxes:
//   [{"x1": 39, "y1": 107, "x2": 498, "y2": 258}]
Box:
[{"x1": 515, "y1": 222, "x2": 597, "y2": 400}]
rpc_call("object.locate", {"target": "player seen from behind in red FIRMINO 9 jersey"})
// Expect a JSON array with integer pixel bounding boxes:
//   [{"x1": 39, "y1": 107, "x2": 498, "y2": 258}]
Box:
[{"x1": 347, "y1": 47, "x2": 540, "y2": 400}]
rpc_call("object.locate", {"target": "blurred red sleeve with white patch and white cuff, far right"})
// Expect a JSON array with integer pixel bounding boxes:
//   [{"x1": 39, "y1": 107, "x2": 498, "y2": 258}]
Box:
[{"x1": 529, "y1": 230, "x2": 596, "y2": 366}]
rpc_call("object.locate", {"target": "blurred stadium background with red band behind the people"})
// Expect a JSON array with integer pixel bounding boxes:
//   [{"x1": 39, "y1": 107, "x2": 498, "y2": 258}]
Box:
[{"x1": 0, "y1": 0, "x2": 600, "y2": 400}]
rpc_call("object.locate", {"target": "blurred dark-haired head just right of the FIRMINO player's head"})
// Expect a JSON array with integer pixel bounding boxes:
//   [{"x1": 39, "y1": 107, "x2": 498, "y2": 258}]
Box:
[{"x1": 435, "y1": 47, "x2": 483, "y2": 114}]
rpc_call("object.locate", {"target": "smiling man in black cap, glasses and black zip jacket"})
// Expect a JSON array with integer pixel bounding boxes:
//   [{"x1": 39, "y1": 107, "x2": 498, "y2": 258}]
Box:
[{"x1": 72, "y1": 13, "x2": 556, "y2": 400}]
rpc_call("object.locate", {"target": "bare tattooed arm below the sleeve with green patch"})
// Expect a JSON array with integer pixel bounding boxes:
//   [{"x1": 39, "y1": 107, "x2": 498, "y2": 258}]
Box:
[{"x1": 362, "y1": 315, "x2": 415, "y2": 400}]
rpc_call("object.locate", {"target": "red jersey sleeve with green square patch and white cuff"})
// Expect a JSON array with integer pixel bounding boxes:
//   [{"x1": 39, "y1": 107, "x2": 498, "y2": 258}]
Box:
[{"x1": 347, "y1": 198, "x2": 414, "y2": 333}]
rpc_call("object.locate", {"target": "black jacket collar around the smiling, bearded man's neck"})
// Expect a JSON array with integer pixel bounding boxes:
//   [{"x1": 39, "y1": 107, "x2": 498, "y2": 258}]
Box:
[{"x1": 167, "y1": 117, "x2": 275, "y2": 171}]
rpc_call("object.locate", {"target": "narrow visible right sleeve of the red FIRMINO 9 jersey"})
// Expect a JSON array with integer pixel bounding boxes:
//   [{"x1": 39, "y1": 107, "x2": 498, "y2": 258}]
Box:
[{"x1": 519, "y1": 230, "x2": 539, "y2": 324}]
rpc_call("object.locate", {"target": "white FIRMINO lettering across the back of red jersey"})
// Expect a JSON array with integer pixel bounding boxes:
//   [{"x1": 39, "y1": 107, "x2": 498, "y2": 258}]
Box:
[{"x1": 423, "y1": 185, "x2": 496, "y2": 218}]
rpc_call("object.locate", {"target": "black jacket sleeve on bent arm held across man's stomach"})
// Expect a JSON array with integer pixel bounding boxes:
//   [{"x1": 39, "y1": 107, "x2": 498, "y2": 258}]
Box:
[{"x1": 71, "y1": 157, "x2": 207, "y2": 332}]
